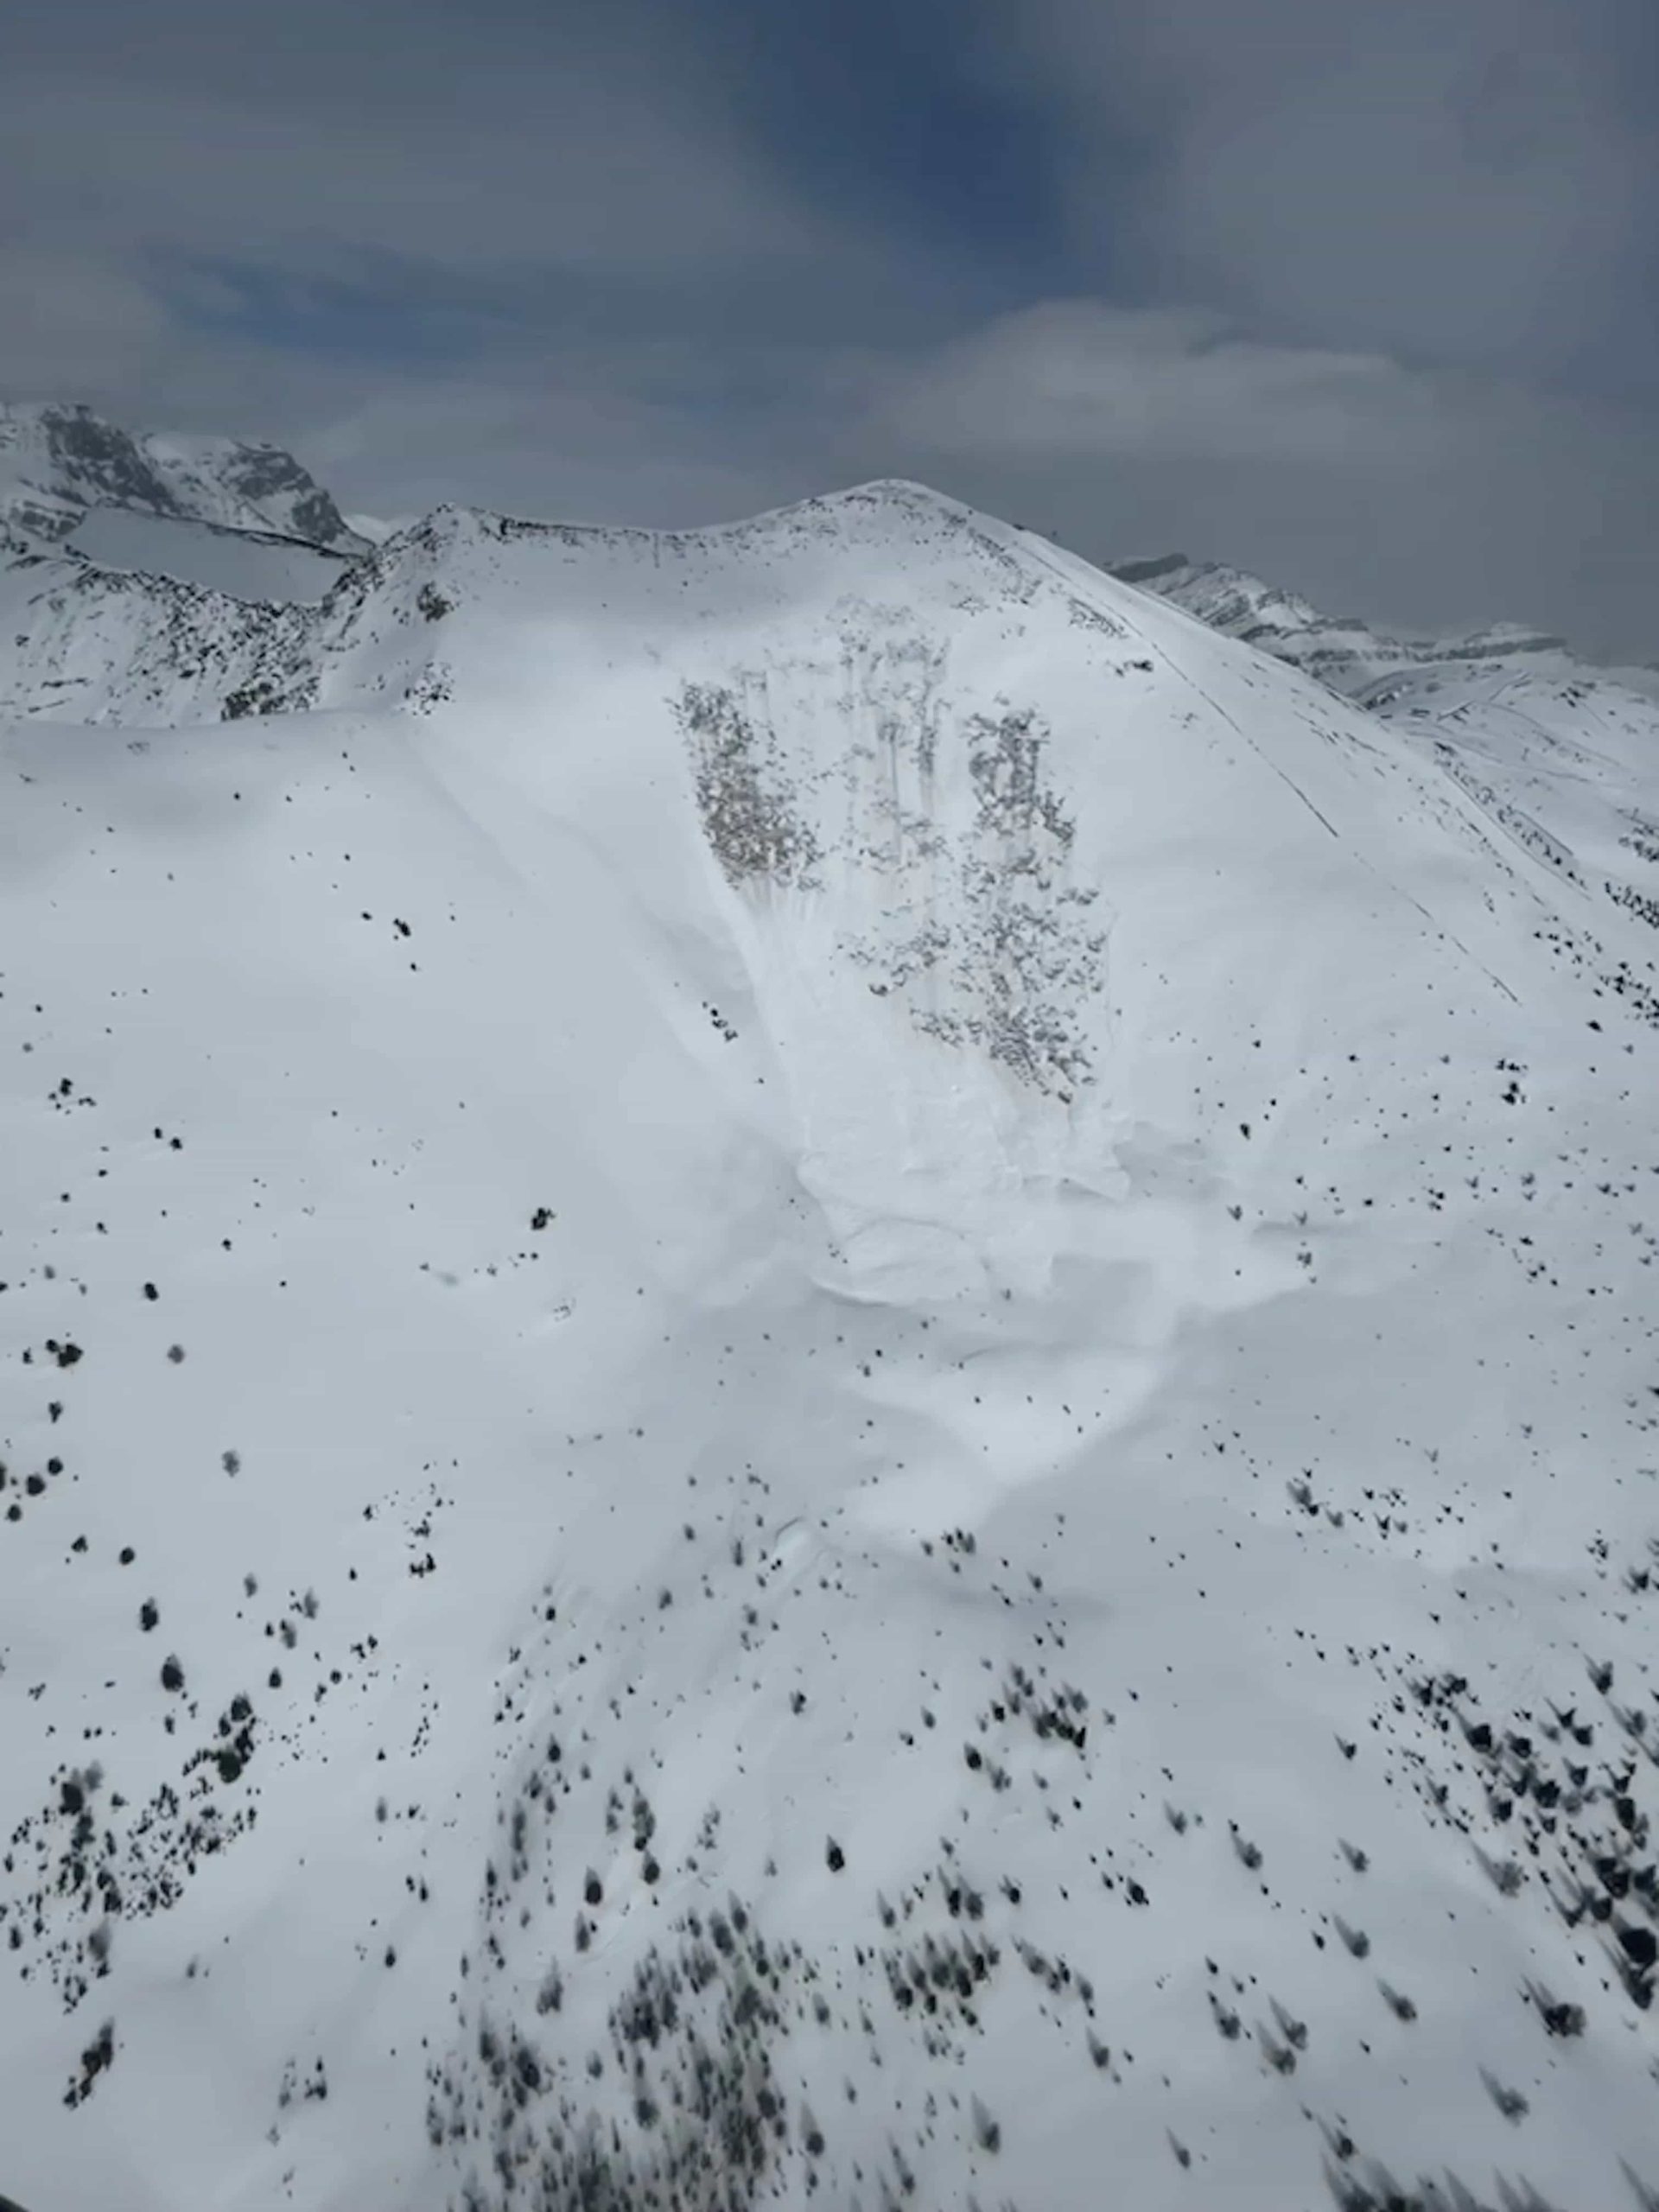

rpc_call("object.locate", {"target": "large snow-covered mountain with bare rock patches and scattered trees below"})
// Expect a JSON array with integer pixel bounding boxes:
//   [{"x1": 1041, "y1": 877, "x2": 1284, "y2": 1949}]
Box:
[{"x1": 0, "y1": 485, "x2": 1659, "y2": 2212}]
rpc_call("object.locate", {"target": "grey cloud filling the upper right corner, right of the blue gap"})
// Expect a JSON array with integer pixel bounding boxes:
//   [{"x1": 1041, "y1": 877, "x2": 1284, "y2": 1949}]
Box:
[{"x1": 980, "y1": 0, "x2": 1659, "y2": 376}]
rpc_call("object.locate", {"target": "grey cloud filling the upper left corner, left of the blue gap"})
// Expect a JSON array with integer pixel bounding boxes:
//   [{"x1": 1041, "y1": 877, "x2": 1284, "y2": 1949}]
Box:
[{"x1": 0, "y1": 0, "x2": 946, "y2": 336}]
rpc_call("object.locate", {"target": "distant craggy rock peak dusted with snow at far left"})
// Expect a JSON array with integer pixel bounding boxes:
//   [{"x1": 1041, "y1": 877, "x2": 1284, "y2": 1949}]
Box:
[{"x1": 0, "y1": 403, "x2": 367, "y2": 553}]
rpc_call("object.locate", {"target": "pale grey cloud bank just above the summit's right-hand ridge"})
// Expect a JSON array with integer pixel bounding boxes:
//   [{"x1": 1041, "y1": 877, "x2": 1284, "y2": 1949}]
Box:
[{"x1": 836, "y1": 299, "x2": 1659, "y2": 659}]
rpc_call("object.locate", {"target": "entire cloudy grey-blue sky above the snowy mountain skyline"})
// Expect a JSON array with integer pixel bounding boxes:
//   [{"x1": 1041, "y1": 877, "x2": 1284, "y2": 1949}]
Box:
[{"x1": 0, "y1": 0, "x2": 1659, "y2": 659}]
